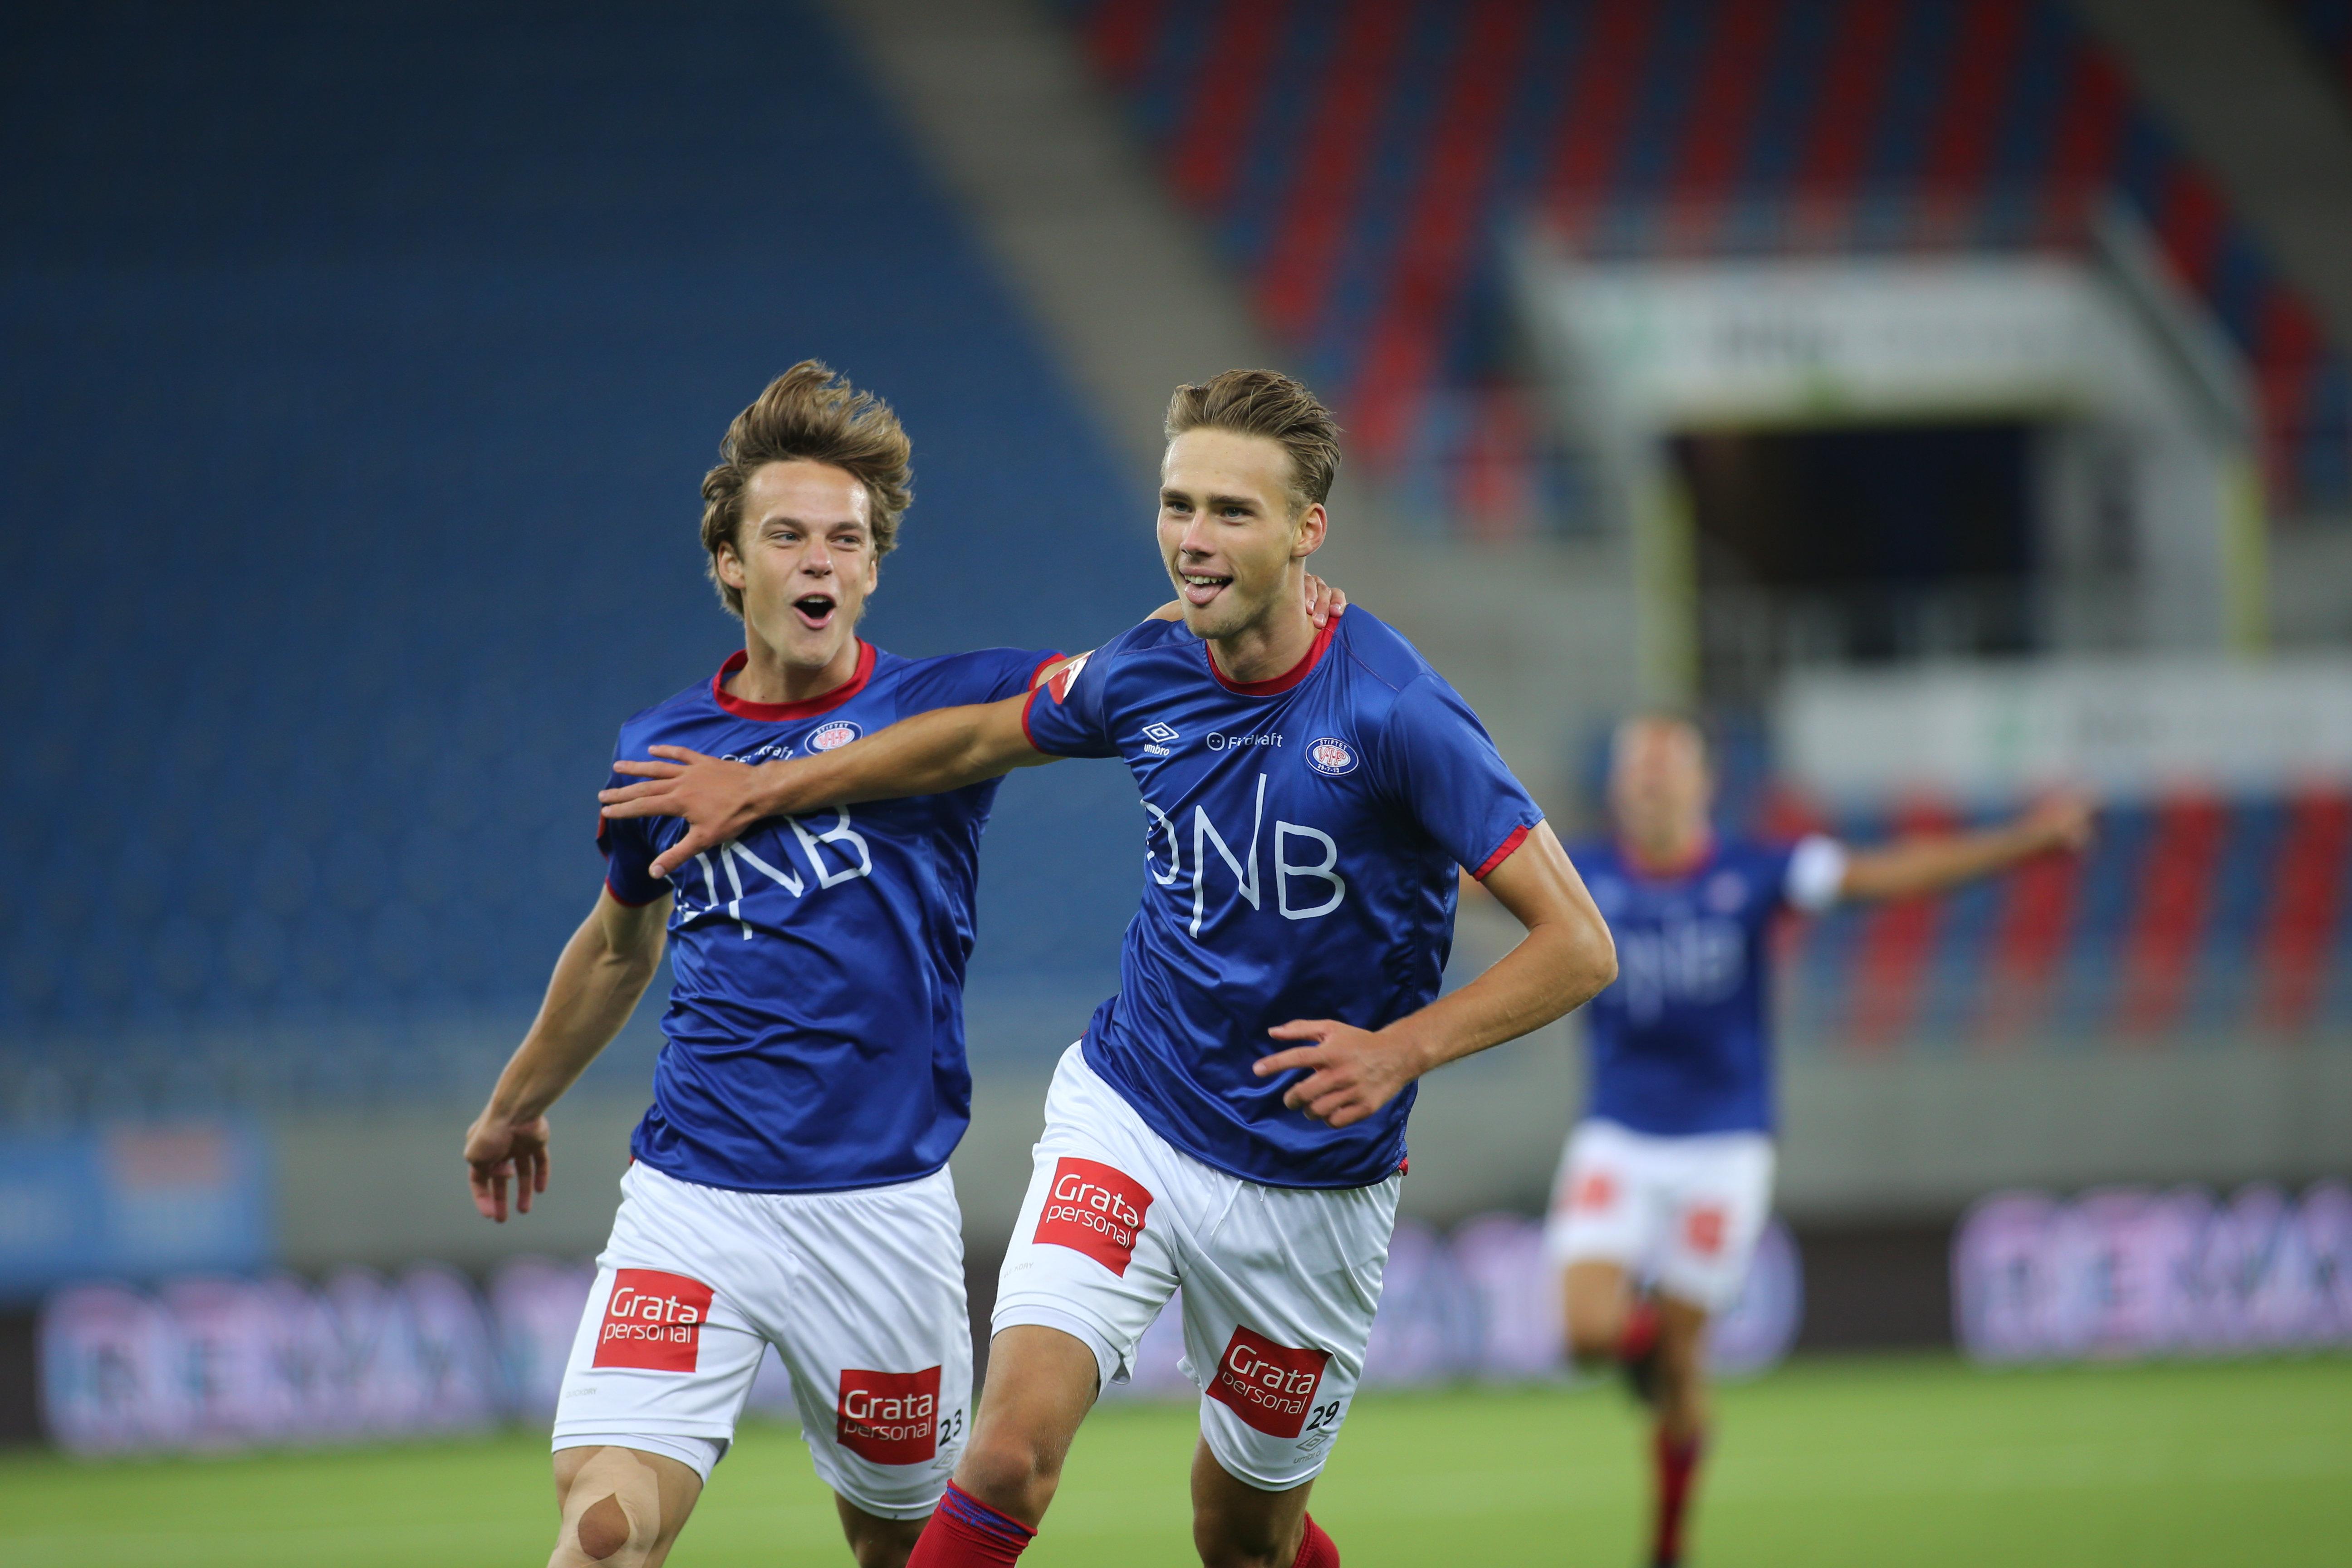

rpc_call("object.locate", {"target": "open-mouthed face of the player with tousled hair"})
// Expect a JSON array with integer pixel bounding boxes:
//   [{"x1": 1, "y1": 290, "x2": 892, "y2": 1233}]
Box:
[{"x1": 715, "y1": 461, "x2": 882, "y2": 670}]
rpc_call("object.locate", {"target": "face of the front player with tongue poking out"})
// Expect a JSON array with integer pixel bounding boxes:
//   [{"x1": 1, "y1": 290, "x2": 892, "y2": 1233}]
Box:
[{"x1": 1160, "y1": 428, "x2": 1327, "y2": 637}]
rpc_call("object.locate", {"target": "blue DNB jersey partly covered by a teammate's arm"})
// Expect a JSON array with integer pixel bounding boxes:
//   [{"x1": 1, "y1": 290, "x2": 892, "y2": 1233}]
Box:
[{"x1": 598, "y1": 642, "x2": 1054, "y2": 1192}]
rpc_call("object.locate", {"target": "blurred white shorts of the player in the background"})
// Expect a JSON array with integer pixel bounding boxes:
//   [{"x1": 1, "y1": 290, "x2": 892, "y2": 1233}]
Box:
[{"x1": 1543, "y1": 1122, "x2": 1774, "y2": 1312}]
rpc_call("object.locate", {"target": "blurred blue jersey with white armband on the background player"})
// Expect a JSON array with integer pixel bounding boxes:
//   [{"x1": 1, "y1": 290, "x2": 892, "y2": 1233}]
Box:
[{"x1": 1571, "y1": 839, "x2": 1844, "y2": 1136}]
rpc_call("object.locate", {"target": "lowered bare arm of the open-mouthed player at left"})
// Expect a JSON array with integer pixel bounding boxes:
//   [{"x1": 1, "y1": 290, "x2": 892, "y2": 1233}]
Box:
[{"x1": 466, "y1": 889, "x2": 670, "y2": 1225}]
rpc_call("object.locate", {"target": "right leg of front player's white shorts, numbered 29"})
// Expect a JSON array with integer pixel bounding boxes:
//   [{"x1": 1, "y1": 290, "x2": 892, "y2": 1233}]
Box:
[{"x1": 1183, "y1": 1178, "x2": 1399, "y2": 1493}]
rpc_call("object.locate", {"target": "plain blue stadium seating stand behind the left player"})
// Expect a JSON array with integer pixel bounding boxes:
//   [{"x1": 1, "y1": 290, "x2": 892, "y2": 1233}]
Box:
[{"x1": 0, "y1": 2, "x2": 1164, "y2": 1122}]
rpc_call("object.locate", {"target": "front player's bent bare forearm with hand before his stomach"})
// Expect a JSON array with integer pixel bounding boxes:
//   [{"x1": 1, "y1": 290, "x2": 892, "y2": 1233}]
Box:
[{"x1": 1256, "y1": 823, "x2": 1616, "y2": 1126}]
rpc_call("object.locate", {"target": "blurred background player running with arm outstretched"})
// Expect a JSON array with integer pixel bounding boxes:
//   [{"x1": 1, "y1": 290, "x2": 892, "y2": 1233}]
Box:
[{"x1": 1545, "y1": 715, "x2": 2091, "y2": 1568}]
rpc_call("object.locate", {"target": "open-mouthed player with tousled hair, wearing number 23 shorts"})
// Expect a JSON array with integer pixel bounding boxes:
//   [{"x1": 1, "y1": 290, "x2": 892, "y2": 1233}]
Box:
[{"x1": 466, "y1": 360, "x2": 1324, "y2": 1568}]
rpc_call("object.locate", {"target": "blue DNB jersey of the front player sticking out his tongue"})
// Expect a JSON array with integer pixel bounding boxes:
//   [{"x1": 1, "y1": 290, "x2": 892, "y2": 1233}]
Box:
[{"x1": 1023, "y1": 609, "x2": 1541, "y2": 1187}]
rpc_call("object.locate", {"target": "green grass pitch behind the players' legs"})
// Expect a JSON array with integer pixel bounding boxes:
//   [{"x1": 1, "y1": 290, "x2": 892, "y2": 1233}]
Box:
[{"x1": 0, "y1": 1357, "x2": 2352, "y2": 1568}]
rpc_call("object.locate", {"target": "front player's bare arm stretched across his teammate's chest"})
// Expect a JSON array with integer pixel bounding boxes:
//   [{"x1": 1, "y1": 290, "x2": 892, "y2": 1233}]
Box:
[{"x1": 598, "y1": 694, "x2": 1061, "y2": 877}]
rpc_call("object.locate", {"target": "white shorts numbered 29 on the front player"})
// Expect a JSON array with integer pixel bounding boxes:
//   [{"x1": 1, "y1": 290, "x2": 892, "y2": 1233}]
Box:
[{"x1": 995, "y1": 1046, "x2": 1402, "y2": 1493}]
